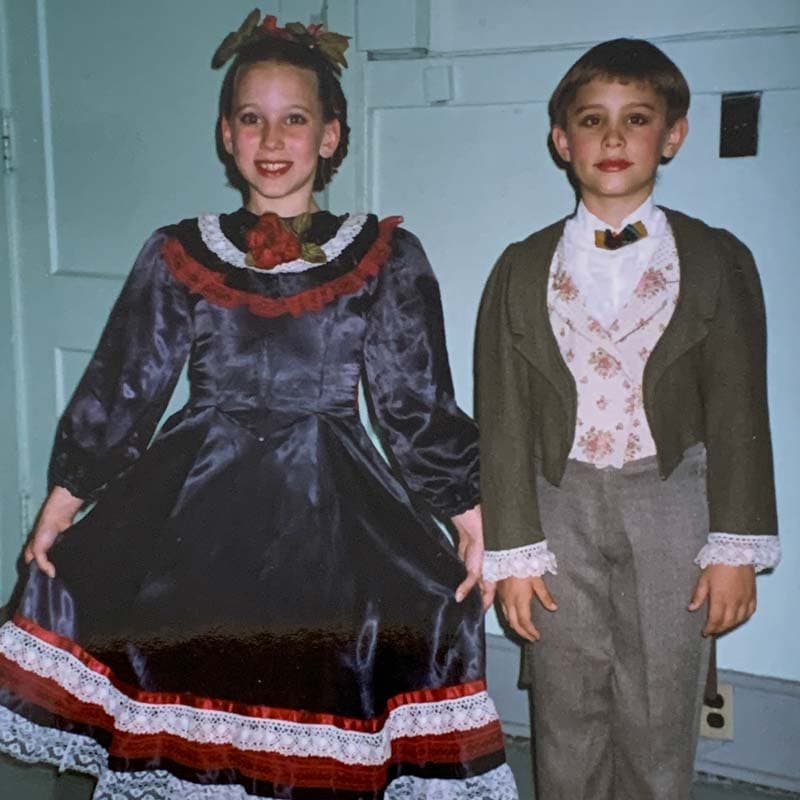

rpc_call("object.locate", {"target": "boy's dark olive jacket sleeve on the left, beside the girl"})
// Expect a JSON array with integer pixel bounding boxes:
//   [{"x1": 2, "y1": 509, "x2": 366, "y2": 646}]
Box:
[{"x1": 476, "y1": 245, "x2": 549, "y2": 556}]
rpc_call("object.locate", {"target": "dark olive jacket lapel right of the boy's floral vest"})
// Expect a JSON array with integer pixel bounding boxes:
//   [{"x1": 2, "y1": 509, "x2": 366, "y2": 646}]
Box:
[{"x1": 644, "y1": 208, "x2": 721, "y2": 402}]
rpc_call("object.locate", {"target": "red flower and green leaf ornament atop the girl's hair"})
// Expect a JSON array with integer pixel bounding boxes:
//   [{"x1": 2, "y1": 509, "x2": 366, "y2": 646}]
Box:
[{"x1": 211, "y1": 8, "x2": 350, "y2": 75}]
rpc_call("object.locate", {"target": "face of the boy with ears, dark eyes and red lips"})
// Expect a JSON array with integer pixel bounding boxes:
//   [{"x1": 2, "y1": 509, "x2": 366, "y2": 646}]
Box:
[{"x1": 552, "y1": 78, "x2": 688, "y2": 224}]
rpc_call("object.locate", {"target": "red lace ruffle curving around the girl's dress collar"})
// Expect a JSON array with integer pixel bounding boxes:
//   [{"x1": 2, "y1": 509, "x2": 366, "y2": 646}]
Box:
[{"x1": 161, "y1": 217, "x2": 403, "y2": 317}]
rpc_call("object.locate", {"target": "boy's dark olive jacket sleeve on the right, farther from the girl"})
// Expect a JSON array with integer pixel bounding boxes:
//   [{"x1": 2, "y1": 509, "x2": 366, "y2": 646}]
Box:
[{"x1": 701, "y1": 231, "x2": 778, "y2": 536}]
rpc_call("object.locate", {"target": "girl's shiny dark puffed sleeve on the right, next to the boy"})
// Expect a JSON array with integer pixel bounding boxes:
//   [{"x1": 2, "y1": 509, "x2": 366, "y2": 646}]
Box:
[{"x1": 364, "y1": 229, "x2": 479, "y2": 517}]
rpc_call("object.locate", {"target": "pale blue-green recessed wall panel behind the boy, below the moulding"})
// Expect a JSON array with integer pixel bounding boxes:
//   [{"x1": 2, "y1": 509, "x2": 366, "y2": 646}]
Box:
[{"x1": 365, "y1": 39, "x2": 800, "y2": 656}]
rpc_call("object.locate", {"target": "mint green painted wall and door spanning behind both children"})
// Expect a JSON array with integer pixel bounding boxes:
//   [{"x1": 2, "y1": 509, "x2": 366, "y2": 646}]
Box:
[{"x1": 0, "y1": 0, "x2": 800, "y2": 712}]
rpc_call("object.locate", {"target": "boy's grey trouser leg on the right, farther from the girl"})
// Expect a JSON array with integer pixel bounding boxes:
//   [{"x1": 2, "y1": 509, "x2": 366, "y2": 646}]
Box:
[{"x1": 612, "y1": 452, "x2": 710, "y2": 800}]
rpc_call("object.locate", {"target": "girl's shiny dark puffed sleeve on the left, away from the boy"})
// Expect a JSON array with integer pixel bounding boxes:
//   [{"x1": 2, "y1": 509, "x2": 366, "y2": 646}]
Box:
[{"x1": 48, "y1": 231, "x2": 191, "y2": 498}]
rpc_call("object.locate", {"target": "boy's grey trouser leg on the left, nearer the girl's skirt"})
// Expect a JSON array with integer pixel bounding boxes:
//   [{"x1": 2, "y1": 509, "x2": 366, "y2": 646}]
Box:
[{"x1": 526, "y1": 466, "x2": 613, "y2": 800}]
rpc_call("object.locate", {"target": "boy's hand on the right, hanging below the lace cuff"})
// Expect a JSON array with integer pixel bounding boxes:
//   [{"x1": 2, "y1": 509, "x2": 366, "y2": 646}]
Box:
[{"x1": 689, "y1": 564, "x2": 756, "y2": 636}]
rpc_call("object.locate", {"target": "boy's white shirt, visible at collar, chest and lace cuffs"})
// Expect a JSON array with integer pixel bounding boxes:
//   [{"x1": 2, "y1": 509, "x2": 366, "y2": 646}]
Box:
[{"x1": 483, "y1": 195, "x2": 781, "y2": 581}]
